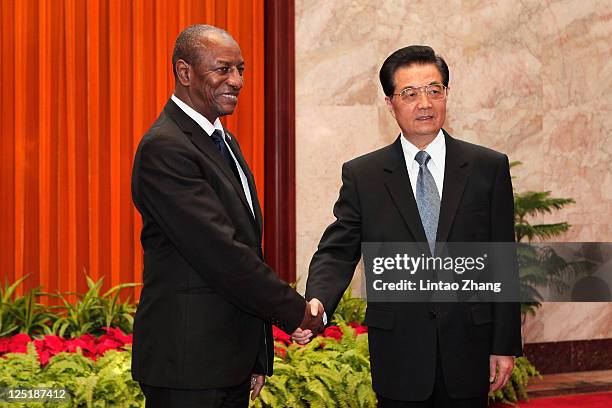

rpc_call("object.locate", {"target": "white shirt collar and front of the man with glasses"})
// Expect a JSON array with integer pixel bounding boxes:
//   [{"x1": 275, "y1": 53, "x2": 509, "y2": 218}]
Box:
[{"x1": 400, "y1": 130, "x2": 446, "y2": 199}]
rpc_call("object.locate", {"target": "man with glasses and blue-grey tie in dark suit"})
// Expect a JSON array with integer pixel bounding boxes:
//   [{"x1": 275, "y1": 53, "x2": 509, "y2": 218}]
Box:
[{"x1": 294, "y1": 46, "x2": 521, "y2": 408}]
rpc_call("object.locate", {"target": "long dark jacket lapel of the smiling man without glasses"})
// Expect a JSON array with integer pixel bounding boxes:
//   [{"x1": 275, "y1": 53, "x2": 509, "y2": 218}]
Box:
[{"x1": 164, "y1": 100, "x2": 261, "y2": 231}]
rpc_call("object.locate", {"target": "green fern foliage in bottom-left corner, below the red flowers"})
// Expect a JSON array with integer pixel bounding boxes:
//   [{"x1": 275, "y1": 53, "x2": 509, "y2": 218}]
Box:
[{"x1": 0, "y1": 344, "x2": 144, "y2": 407}]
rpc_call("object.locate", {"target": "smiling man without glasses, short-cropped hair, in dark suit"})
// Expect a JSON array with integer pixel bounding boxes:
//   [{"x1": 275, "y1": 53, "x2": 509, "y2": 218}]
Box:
[{"x1": 132, "y1": 25, "x2": 322, "y2": 408}]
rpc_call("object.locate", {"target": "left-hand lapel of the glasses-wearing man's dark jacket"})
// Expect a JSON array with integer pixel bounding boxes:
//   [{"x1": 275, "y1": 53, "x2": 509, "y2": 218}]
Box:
[{"x1": 383, "y1": 136, "x2": 427, "y2": 242}]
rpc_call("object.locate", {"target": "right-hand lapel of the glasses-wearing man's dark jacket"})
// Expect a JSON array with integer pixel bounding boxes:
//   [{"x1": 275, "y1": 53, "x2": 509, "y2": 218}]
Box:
[{"x1": 436, "y1": 131, "x2": 471, "y2": 247}]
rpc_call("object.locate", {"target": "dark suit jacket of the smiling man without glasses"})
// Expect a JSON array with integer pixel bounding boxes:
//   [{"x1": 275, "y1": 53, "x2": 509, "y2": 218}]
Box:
[{"x1": 132, "y1": 100, "x2": 305, "y2": 389}]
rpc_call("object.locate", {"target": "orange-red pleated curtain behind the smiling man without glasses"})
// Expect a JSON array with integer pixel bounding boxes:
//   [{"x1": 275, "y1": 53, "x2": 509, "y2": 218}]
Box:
[{"x1": 0, "y1": 0, "x2": 264, "y2": 295}]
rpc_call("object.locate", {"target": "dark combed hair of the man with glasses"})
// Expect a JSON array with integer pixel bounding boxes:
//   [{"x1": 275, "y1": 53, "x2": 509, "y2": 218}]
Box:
[{"x1": 378, "y1": 45, "x2": 449, "y2": 96}]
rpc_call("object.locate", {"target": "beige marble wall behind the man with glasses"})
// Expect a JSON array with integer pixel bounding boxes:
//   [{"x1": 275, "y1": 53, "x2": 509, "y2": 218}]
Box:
[{"x1": 295, "y1": 0, "x2": 612, "y2": 342}]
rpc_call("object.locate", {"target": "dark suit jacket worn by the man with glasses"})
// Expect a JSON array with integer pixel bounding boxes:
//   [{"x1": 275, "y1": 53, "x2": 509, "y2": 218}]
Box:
[{"x1": 306, "y1": 133, "x2": 521, "y2": 401}]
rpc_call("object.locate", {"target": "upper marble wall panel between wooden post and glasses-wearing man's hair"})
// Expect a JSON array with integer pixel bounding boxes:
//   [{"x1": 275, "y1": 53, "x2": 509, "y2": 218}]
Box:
[{"x1": 295, "y1": 0, "x2": 380, "y2": 106}]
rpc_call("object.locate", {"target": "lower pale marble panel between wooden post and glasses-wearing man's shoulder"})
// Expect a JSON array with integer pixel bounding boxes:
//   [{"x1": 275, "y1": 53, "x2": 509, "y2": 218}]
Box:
[{"x1": 296, "y1": 105, "x2": 386, "y2": 290}]
